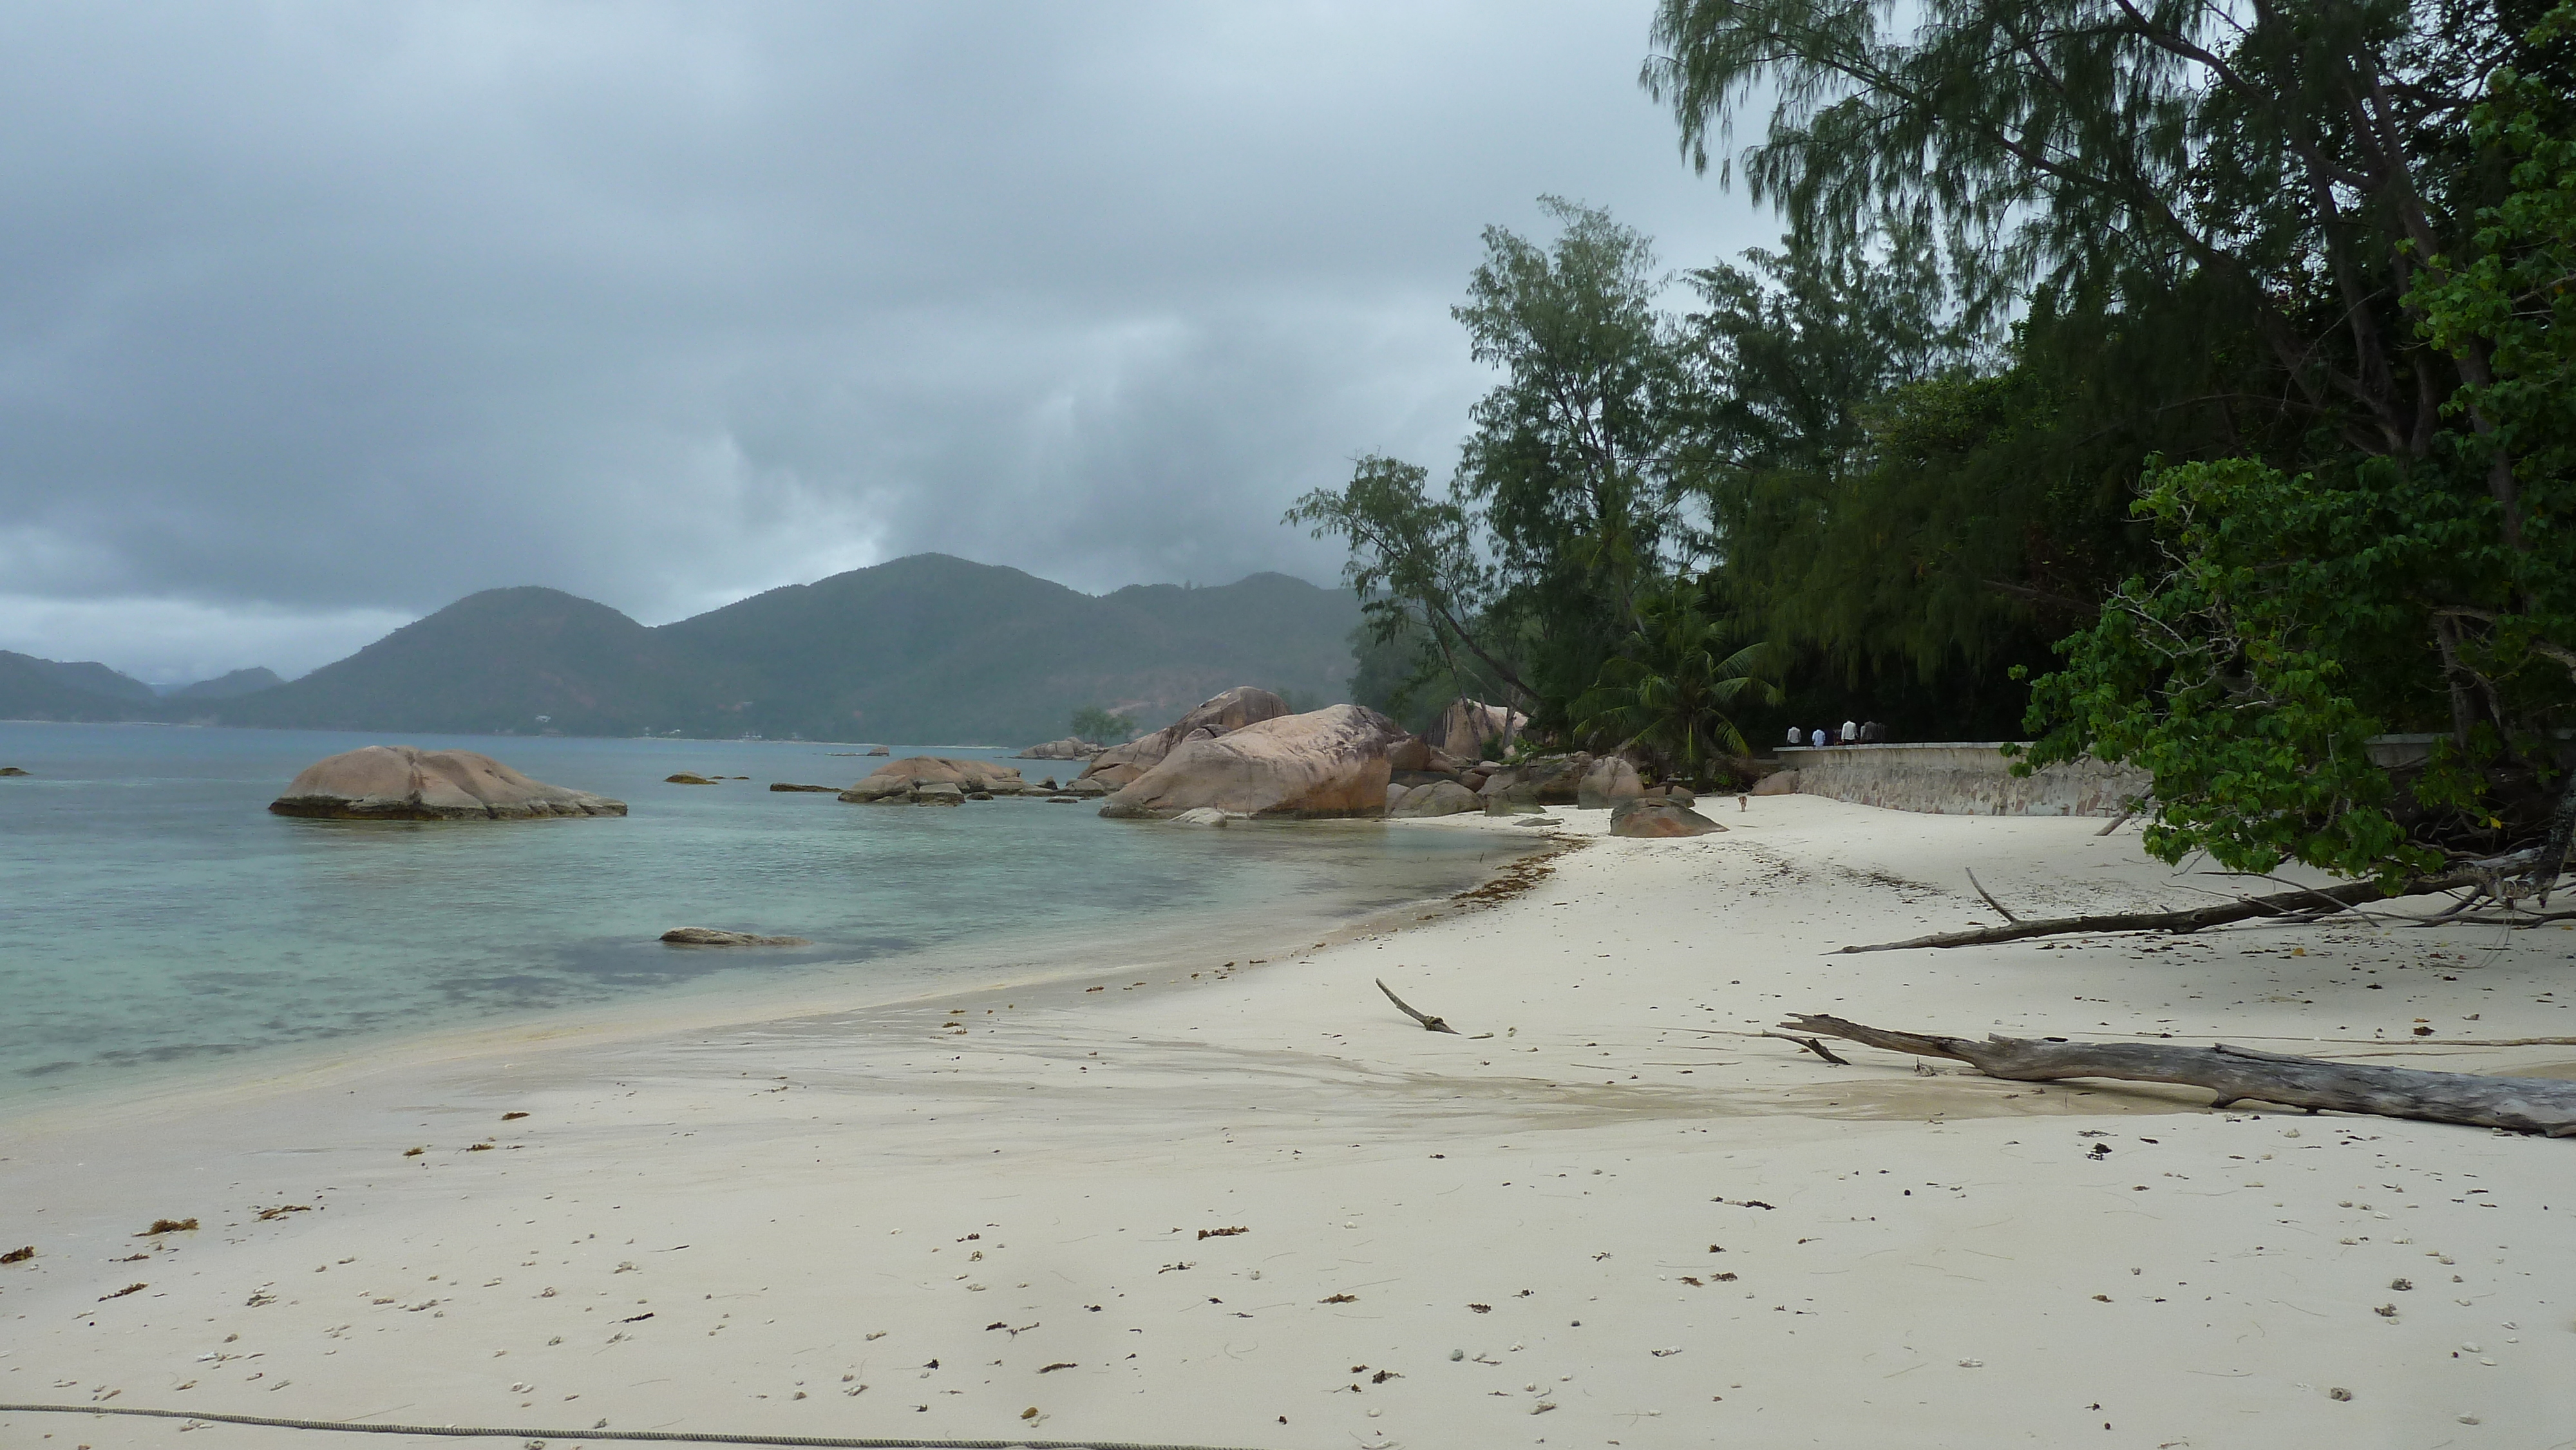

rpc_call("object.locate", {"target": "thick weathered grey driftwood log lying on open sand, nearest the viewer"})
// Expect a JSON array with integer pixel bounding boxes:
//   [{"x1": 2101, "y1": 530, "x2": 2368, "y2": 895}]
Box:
[{"x1": 1780, "y1": 1015, "x2": 2576, "y2": 1138}]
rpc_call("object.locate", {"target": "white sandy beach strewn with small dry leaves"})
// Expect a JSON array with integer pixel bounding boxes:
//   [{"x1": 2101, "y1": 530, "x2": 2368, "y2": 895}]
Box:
[{"x1": 0, "y1": 796, "x2": 2576, "y2": 1450}]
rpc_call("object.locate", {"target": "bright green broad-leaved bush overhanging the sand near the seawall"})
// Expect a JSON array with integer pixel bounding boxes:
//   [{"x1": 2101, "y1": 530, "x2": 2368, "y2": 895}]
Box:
[{"x1": 2027, "y1": 458, "x2": 2481, "y2": 878}]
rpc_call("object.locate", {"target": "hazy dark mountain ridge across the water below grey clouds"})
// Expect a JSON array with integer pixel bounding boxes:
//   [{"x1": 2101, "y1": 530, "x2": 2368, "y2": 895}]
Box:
[{"x1": 0, "y1": 554, "x2": 1360, "y2": 744}]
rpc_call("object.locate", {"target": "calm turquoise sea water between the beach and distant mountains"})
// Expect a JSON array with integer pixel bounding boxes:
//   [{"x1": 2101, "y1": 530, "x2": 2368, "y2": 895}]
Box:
[{"x1": 0, "y1": 721, "x2": 1499, "y2": 1102}]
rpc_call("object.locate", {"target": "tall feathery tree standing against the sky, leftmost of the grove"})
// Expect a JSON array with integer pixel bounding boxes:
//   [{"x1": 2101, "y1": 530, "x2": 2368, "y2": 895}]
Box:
[{"x1": 1285, "y1": 198, "x2": 1700, "y2": 729}]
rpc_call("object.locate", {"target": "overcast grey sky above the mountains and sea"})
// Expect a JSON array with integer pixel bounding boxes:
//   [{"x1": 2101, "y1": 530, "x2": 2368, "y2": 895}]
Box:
[{"x1": 0, "y1": 0, "x2": 1777, "y2": 683}]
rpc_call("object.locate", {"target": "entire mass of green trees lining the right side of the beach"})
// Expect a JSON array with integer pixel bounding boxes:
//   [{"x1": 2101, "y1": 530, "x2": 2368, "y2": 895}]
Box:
[{"x1": 1291, "y1": 0, "x2": 2576, "y2": 845}]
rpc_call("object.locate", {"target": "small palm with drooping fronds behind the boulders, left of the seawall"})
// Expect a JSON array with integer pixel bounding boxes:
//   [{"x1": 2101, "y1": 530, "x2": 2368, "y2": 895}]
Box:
[{"x1": 1571, "y1": 587, "x2": 1783, "y2": 780}]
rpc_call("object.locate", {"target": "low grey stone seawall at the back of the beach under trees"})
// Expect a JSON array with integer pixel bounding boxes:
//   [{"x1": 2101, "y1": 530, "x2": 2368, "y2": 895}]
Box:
[{"x1": 1780, "y1": 742, "x2": 2148, "y2": 816}]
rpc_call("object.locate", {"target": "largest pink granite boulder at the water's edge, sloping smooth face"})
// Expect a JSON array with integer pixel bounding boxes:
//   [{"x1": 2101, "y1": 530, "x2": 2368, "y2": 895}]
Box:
[{"x1": 1100, "y1": 706, "x2": 1404, "y2": 816}]
